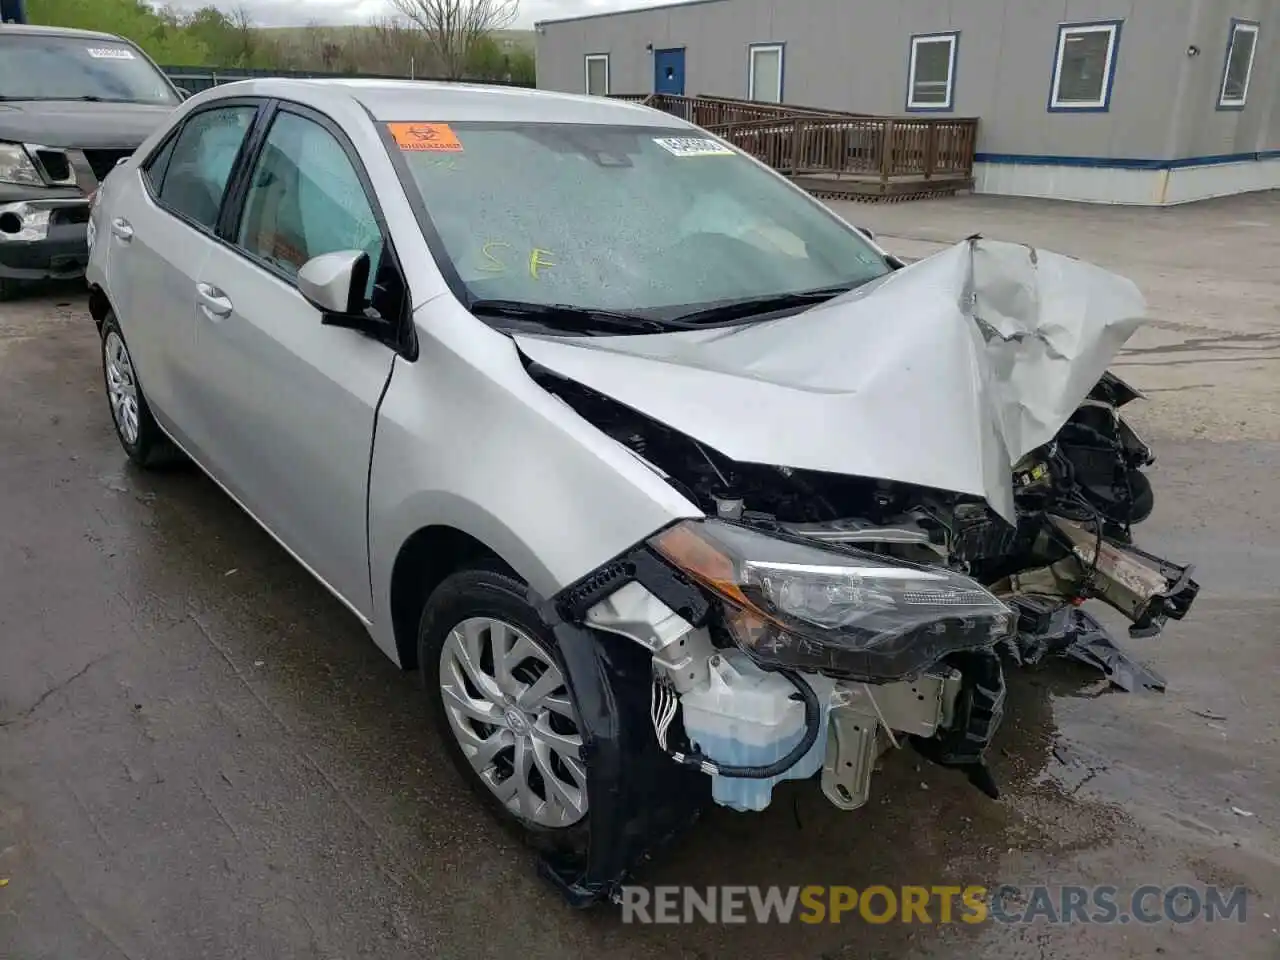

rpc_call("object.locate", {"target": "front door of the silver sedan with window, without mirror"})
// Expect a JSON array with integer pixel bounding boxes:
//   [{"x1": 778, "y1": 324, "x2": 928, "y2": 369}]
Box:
[{"x1": 184, "y1": 104, "x2": 406, "y2": 618}]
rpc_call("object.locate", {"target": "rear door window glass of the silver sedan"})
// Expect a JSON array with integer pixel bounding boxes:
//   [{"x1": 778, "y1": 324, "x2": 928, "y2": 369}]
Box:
[{"x1": 160, "y1": 105, "x2": 257, "y2": 229}]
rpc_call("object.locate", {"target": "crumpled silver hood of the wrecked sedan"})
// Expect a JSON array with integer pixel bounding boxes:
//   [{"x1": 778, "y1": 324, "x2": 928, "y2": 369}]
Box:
[{"x1": 516, "y1": 238, "x2": 1146, "y2": 521}]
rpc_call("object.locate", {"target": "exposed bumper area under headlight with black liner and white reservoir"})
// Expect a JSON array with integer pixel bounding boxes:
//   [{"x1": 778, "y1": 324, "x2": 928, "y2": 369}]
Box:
[{"x1": 540, "y1": 537, "x2": 1011, "y2": 906}]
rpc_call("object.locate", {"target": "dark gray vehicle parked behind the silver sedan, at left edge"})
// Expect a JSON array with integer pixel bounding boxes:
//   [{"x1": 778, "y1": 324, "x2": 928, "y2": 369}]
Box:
[{"x1": 0, "y1": 24, "x2": 183, "y2": 300}]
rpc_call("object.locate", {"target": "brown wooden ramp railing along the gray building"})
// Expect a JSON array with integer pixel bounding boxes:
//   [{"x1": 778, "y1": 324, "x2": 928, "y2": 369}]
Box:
[{"x1": 611, "y1": 93, "x2": 978, "y2": 193}]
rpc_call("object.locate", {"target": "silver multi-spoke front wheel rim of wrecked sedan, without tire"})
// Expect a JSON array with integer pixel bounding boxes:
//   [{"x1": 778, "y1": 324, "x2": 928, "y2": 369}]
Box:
[{"x1": 440, "y1": 617, "x2": 586, "y2": 827}]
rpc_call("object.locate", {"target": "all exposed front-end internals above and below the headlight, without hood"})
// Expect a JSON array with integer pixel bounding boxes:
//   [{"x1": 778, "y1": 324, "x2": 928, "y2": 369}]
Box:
[{"x1": 534, "y1": 370, "x2": 1198, "y2": 834}]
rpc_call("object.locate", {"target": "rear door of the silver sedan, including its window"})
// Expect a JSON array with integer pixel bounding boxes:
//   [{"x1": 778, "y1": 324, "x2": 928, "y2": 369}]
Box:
[{"x1": 106, "y1": 100, "x2": 260, "y2": 445}]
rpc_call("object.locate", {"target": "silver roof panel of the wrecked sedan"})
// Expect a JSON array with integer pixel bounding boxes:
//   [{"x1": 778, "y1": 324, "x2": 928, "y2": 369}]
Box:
[{"x1": 198, "y1": 77, "x2": 691, "y2": 128}]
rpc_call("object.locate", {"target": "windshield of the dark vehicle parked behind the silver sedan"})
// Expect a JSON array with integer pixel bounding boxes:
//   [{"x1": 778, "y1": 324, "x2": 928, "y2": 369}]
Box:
[{"x1": 0, "y1": 33, "x2": 178, "y2": 105}]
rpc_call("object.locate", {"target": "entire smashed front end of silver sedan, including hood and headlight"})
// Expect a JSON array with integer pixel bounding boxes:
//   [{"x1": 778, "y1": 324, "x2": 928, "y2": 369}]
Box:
[{"x1": 517, "y1": 239, "x2": 1199, "y2": 911}]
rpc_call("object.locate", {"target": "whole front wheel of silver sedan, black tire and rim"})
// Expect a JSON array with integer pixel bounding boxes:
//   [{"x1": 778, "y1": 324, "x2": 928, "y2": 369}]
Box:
[{"x1": 419, "y1": 570, "x2": 590, "y2": 856}]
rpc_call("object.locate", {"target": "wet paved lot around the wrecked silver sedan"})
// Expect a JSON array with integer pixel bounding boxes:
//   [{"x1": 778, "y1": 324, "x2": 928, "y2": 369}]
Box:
[{"x1": 0, "y1": 195, "x2": 1280, "y2": 960}]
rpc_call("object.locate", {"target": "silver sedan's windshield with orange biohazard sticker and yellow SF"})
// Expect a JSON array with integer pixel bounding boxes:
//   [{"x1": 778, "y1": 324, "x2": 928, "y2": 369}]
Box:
[{"x1": 389, "y1": 123, "x2": 890, "y2": 319}]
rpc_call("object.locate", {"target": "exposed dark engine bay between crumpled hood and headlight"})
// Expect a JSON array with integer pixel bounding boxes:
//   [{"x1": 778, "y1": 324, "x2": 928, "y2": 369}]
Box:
[{"x1": 538, "y1": 372, "x2": 1197, "y2": 662}]
